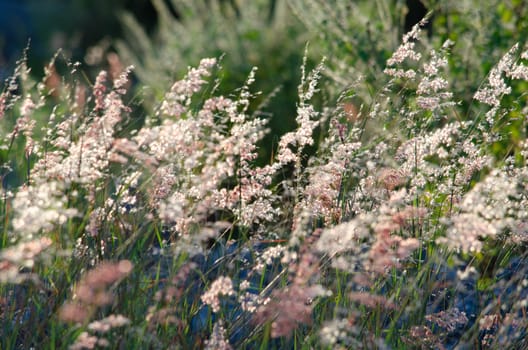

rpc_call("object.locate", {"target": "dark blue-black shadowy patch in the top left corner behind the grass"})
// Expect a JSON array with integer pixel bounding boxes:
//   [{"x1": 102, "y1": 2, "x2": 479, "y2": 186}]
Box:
[{"x1": 0, "y1": 0, "x2": 157, "y2": 78}]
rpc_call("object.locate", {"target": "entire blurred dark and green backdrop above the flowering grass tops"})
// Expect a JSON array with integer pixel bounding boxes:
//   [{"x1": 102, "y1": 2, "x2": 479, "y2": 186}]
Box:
[{"x1": 0, "y1": 0, "x2": 528, "y2": 161}]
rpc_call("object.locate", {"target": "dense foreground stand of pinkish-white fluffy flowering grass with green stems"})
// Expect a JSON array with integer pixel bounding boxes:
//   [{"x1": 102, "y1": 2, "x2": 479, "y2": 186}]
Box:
[{"x1": 0, "y1": 1, "x2": 528, "y2": 349}]
